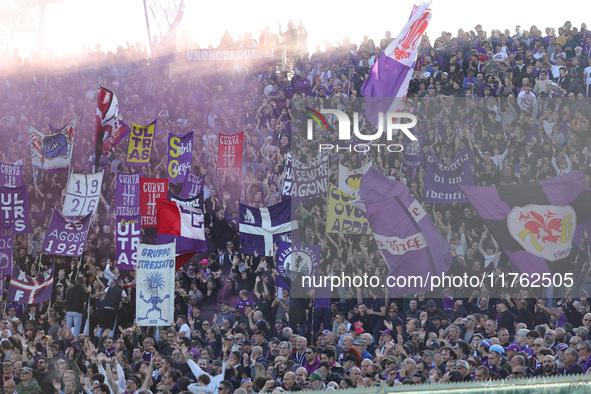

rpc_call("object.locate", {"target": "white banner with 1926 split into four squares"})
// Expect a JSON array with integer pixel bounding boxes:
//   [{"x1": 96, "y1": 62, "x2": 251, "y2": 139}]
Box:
[{"x1": 62, "y1": 171, "x2": 104, "y2": 216}]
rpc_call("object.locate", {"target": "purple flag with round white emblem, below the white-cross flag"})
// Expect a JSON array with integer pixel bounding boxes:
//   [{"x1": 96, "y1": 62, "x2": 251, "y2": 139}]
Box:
[{"x1": 275, "y1": 241, "x2": 322, "y2": 289}]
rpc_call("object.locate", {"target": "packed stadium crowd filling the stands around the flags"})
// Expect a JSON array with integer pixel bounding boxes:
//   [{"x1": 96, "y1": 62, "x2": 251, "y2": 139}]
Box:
[{"x1": 0, "y1": 16, "x2": 591, "y2": 394}]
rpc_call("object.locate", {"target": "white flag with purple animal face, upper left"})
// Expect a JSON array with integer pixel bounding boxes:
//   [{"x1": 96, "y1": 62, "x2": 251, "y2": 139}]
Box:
[{"x1": 29, "y1": 120, "x2": 76, "y2": 170}]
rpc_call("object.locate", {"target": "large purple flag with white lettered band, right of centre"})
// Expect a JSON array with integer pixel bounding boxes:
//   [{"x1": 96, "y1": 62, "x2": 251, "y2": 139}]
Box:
[{"x1": 353, "y1": 167, "x2": 452, "y2": 297}]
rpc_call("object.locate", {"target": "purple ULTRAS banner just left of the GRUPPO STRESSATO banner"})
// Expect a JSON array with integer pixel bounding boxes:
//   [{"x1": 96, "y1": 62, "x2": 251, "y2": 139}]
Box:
[{"x1": 117, "y1": 215, "x2": 142, "y2": 270}]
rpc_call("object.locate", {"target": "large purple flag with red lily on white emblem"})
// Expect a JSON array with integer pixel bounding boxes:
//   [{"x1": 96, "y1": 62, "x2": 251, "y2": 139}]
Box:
[{"x1": 461, "y1": 171, "x2": 591, "y2": 274}]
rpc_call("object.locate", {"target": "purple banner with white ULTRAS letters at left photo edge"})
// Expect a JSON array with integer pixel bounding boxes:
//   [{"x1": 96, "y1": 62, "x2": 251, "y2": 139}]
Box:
[{"x1": 0, "y1": 186, "x2": 29, "y2": 234}]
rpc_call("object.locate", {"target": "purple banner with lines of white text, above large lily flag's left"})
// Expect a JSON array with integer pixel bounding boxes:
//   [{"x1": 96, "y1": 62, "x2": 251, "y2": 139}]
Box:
[{"x1": 423, "y1": 148, "x2": 474, "y2": 204}]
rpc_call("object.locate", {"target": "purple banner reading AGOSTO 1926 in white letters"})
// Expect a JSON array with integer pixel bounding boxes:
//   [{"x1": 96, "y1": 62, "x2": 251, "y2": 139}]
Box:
[{"x1": 43, "y1": 210, "x2": 92, "y2": 256}]
